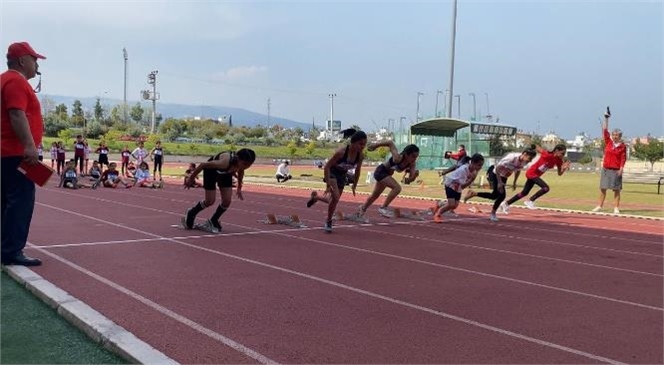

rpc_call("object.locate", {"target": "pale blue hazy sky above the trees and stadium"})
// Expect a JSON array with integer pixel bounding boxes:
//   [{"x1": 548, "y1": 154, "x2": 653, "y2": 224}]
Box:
[{"x1": 0, "y1": 0, "x2": 664, "y2": 138}]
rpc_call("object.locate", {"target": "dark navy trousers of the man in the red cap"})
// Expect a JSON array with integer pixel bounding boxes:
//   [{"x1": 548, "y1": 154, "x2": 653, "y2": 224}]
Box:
[{"x1": 1, "y1": 157, "x2": 35, "y2": 260}]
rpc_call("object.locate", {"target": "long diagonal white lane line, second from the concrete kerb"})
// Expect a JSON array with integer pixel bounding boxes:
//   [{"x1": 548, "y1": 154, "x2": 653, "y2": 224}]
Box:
[{"x1": 33, "y1": 204, "x2": 624, "y2": 365}]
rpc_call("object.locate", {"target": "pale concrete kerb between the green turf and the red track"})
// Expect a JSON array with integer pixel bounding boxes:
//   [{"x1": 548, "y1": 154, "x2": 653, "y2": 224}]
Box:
[{"x1": 2, "y1": 265, "x2": 178, "y2": 365}]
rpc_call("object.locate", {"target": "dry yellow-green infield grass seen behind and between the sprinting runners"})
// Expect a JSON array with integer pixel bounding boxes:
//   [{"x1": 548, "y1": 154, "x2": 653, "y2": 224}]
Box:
[{"x1": 164, "y1": 165, "x2": 664, "y2": 218}]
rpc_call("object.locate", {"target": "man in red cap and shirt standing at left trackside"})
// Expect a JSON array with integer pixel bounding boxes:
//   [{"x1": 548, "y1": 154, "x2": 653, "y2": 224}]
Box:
[{"x1": 0, "y1": 42, "x2": 46, "y2": 266}]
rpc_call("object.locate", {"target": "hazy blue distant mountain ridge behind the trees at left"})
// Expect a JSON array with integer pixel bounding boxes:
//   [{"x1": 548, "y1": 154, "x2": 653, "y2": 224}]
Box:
[{"x1": 40, "y1": 94, "x2": 312, "y2": 131}]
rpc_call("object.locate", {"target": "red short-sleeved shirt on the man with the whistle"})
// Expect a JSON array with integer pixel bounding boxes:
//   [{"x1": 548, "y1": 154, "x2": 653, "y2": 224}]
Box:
[{"x1": 0, "y1": 70, "x2": 44, "y2": 157}]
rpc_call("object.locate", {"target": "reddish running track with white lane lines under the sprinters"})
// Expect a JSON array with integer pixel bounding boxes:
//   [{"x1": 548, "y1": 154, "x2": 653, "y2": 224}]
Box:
[{"x1": 23, "y1": 179, "x2": 664, "y2": 364}]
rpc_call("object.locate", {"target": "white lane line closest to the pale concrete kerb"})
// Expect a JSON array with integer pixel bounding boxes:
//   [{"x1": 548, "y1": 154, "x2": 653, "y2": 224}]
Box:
[{"x1": 27, "y1": 243, "x2": 277, "y2": 364}]
